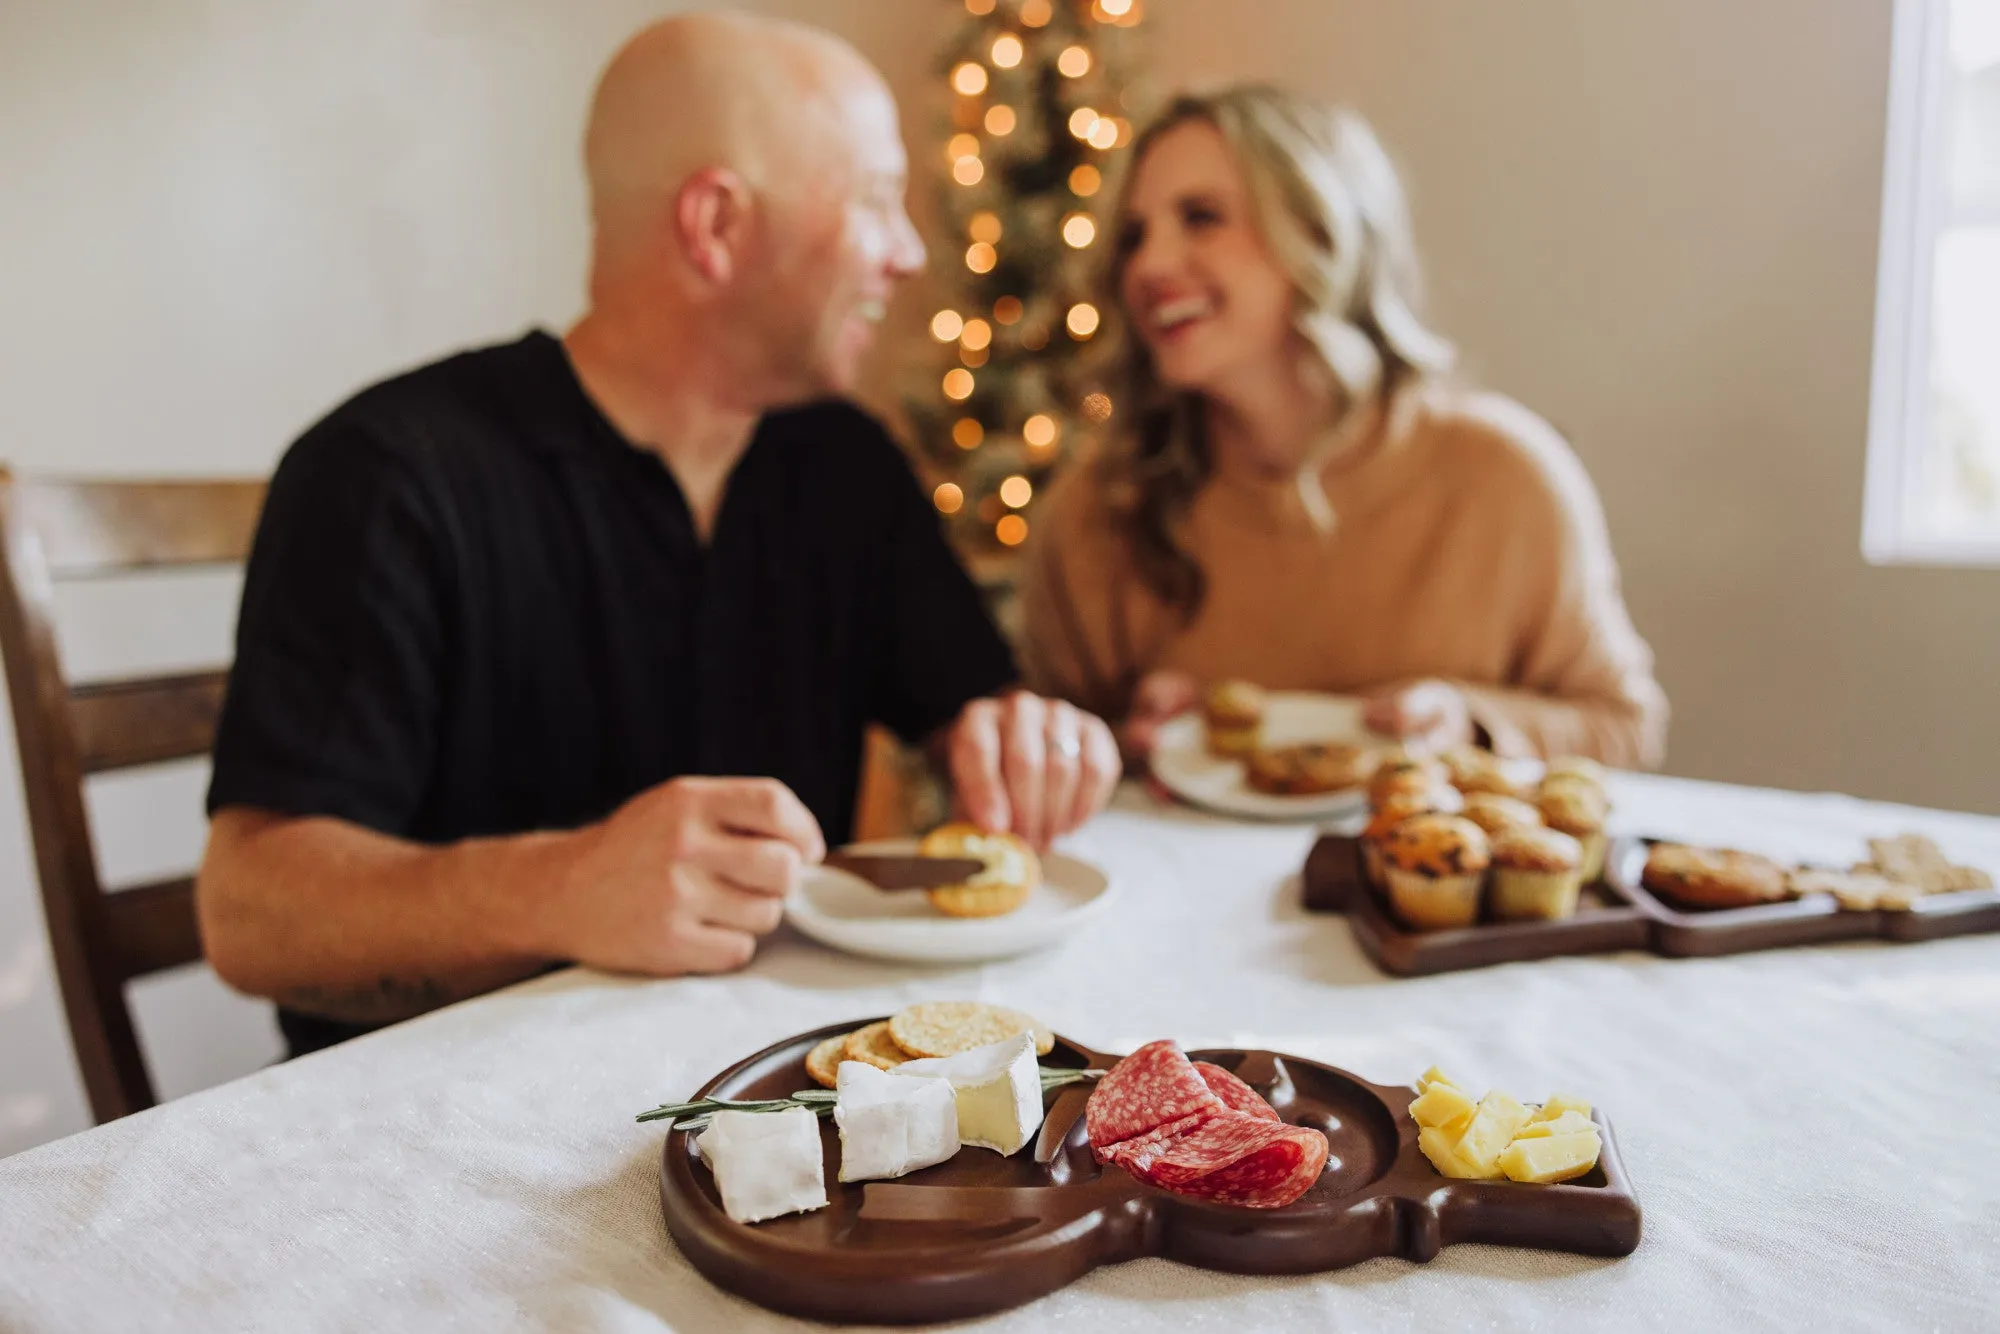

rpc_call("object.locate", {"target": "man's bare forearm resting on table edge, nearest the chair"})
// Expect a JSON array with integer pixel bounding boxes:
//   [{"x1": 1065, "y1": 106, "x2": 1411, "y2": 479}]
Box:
[{"x1": 196, "y1": 808, "x2": 574, "y2": 1022}]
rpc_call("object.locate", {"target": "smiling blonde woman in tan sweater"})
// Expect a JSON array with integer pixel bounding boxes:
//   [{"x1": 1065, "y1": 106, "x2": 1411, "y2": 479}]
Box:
[{"x1": 1022, "y1": 86, "x2": 1666, "y2": 768}]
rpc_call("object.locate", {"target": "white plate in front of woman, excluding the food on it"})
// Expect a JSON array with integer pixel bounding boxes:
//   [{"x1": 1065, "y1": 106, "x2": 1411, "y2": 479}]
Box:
[{"x1": 1152, "y1": 690, "x2": 1394, "y2": 820}]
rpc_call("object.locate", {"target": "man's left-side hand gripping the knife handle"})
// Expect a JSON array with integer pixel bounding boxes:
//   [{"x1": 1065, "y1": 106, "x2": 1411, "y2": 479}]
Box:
[{"x1": 548, "y1": 778, "x2": 826, "y2": 976}]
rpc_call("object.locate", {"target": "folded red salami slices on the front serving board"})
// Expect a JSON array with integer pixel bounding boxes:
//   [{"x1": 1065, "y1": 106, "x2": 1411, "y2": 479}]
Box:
[{"x1": 1084, "y1": 1042, "x2": 1328, "y2": 1208}]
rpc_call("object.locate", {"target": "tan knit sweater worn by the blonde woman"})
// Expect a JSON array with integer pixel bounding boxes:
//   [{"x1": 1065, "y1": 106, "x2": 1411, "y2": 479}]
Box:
[{"x1": 1022, "y1": 384, "x2": 1666, "y2": 768}]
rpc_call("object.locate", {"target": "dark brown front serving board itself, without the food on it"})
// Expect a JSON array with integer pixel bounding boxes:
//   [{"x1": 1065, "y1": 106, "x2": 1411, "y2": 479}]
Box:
[{"x1": 660, "y1": 1020, "x2": 1640, "y2": 1324}]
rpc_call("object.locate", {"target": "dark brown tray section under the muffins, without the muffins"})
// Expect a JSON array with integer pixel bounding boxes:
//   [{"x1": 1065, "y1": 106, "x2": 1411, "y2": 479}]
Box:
[{"x1": 1302, "y1": 834, "x2": 1652, "y2": 978}]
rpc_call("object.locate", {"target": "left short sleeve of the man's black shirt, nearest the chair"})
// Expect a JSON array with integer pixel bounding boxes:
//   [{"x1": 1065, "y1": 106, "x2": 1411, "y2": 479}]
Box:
[{"x1": 208, "y1": 424, "x2": 448, "y2": 834}]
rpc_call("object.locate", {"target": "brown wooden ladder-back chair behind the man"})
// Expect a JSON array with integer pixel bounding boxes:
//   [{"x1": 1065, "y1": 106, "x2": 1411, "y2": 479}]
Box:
[{"x1": 0, "y1": 468, "x2": 264, "y2": 1122}]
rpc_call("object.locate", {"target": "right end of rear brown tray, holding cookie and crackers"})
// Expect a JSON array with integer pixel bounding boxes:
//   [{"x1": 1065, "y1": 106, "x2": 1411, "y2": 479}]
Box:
[{"x1": 1608, "y1": 834, "x2": 2000, "y2": 958}]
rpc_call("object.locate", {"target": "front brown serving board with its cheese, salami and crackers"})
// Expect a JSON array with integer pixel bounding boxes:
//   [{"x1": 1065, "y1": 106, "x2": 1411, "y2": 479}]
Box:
[{"x1": 640, "y1": 1002, "x2": 1640, "y2": 1324}]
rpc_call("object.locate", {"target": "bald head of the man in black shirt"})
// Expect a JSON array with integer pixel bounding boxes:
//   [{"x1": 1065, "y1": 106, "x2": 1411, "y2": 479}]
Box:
[{"x1": 584, "y1": 14, "x2": 924, "y2": 410}]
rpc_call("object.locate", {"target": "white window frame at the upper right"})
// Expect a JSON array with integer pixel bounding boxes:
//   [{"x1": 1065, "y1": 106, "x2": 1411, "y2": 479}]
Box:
[{"x1": 1862, "y1": 0, "x2": 2000, "y2": 566}]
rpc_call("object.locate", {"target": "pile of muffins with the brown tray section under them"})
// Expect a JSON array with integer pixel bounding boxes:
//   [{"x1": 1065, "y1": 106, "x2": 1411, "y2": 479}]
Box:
[{"x1": 1302, "y1": 748, "x2": 1650, "y2": 976}]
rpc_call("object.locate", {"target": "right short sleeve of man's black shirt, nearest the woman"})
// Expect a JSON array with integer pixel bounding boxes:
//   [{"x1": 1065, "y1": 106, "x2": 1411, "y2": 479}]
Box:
[{"x1": 870, "y1": 438, "x2": 1018, "y2": 746}]
